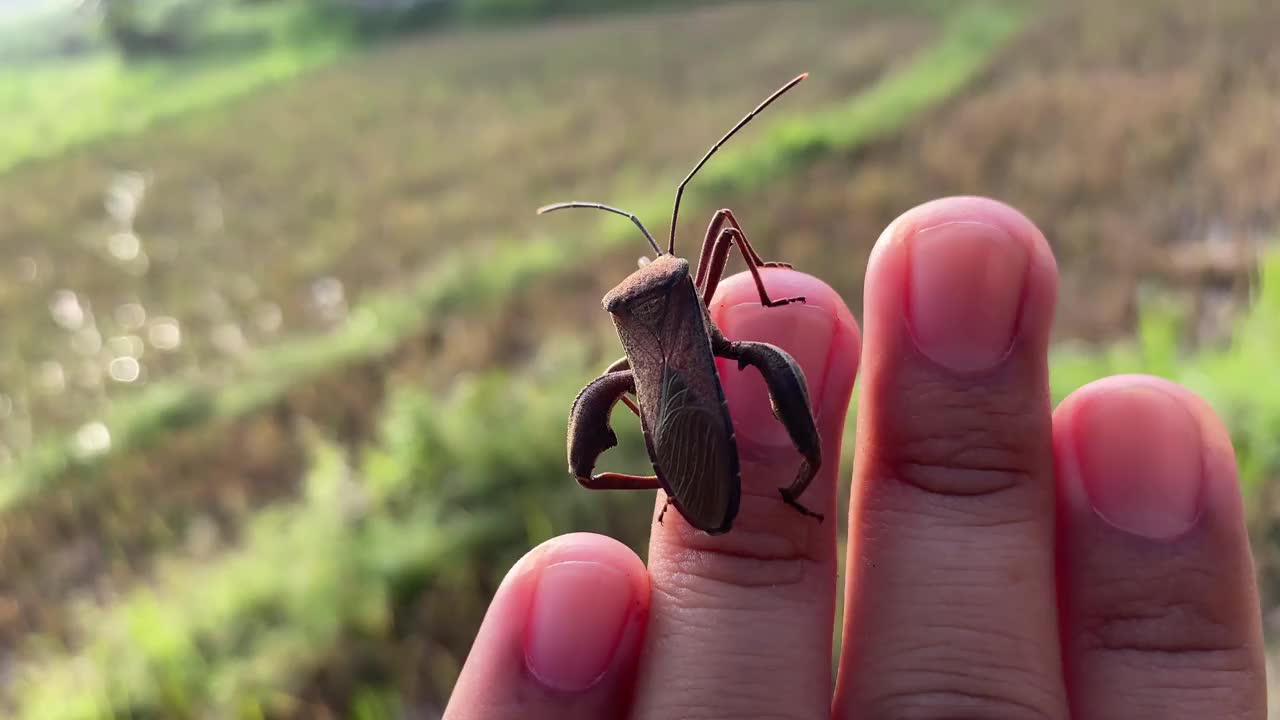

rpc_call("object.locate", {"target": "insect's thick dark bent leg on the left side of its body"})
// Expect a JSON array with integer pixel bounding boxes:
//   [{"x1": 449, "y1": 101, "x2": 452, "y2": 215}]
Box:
[{"x1": 568, "y1": 370, "x2": 662, "y2": 489}]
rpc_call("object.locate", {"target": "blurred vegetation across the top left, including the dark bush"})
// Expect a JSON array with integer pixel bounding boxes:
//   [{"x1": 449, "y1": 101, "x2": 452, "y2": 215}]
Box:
[{"x1": 0, "y1": 0, "x2": 747, "y2": 172}]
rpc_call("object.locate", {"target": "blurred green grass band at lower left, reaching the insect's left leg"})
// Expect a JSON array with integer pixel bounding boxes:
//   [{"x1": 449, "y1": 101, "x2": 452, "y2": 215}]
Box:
[{"x1": 10, "y1": 345, "x2": 648, "y2": 720}]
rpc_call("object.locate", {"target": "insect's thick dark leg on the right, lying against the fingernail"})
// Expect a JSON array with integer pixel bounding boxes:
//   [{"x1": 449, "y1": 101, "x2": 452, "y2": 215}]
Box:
[{"x1": 714, "y1": 337, "x2": 822, "y2": 521}]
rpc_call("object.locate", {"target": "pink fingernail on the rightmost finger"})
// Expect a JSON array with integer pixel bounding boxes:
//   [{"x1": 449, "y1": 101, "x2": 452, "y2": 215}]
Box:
[{"x1": 1074, "y1": 387, "x2": 1204, "y2": 539}]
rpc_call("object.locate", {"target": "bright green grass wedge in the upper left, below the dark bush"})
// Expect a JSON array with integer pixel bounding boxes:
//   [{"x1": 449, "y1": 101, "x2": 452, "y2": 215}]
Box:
[{"x1": 0, "y1": 3, "x2": 356, "y2": 172}]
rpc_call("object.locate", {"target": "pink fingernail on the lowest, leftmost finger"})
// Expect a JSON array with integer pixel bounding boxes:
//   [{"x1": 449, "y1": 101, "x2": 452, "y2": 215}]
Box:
[{"x1": 525, "y1": 561, "x2": 635, "y2": 692}]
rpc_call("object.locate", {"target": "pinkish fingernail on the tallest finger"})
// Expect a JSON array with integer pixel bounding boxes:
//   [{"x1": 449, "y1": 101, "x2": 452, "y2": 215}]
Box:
[{"x1": 906, "y1": 222, "x2": 1029, "y2": 373}]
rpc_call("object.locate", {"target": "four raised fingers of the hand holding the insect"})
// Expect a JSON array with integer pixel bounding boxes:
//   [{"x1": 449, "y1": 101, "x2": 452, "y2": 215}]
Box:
[{"x1": 444, "y1": 197, "x2": 1266, "y2": 720}]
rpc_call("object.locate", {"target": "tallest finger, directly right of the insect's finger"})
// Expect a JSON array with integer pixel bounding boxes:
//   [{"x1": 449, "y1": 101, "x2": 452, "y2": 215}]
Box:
[{"x1": 836, "y1": 197, "x2": 1066, "y2": 717}]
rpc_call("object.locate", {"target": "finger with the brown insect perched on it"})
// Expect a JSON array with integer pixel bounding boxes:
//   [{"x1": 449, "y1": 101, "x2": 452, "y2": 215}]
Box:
[{"x1": 634, "y1": 269, "x2": 859, "y2": 719}]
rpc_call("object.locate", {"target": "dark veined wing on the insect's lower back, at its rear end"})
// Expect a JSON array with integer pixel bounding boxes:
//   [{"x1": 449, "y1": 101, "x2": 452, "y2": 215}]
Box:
[{"x1": 654, "y1": 366, "x2": 737, "y2": 532}]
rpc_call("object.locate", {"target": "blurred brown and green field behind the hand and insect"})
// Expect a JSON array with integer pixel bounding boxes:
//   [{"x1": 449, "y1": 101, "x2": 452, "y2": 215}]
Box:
[{"x1": 0, "y1": 0, "x2": 1280, "y2": 719}]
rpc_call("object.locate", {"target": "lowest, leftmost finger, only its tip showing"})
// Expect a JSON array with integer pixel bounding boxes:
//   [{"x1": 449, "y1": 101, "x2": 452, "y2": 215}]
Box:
[{"x1": 444, "y1": 533, "x2": 649, "y2": 720}]
